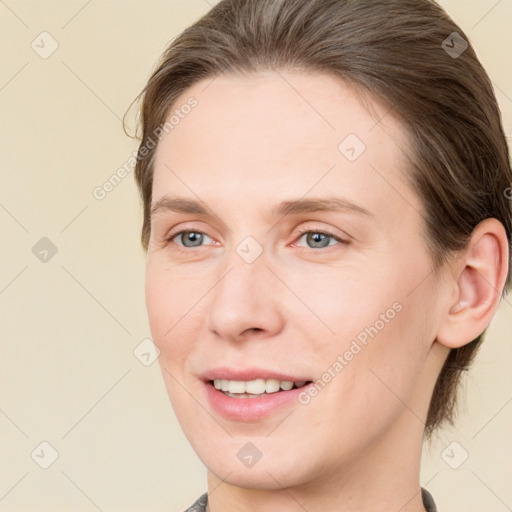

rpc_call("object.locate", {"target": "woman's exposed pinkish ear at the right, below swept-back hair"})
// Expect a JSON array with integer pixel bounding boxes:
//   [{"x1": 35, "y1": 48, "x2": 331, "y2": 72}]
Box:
[{"x1": 437, "y1": 219, "x2": 509, "y2": 348}]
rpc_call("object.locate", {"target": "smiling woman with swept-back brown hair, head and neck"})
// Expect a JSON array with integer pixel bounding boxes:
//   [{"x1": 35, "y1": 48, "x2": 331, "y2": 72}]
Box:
[{"x1": 126, "y1": 0, "x2": 512, "y2": 512}]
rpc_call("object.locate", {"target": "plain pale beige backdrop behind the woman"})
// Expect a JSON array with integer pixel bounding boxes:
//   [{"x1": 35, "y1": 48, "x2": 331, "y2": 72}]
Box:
[{"x1": 0, "y1": 0, "x2": 512, "y2": 512}]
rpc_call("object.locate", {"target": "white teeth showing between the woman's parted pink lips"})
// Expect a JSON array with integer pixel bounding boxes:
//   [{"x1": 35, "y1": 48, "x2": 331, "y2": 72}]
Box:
[{"x1": 209, "y1": 379, "x2": 312, "y2": 398}]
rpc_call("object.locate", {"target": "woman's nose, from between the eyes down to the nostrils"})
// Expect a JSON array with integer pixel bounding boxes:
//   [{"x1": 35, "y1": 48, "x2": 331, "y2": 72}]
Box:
[{"x1": 206, "y1": 249, "x2": 284, "y2": 342}]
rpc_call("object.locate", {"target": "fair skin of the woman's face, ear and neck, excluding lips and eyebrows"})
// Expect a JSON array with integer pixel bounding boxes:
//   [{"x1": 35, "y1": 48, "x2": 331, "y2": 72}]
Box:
[{"x1": 146, "y1": 71, "x2": 508, "y2": 512}]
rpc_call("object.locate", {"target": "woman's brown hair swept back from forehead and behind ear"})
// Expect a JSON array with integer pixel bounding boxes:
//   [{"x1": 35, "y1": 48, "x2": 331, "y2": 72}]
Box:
[{"x1": 124, "y1": 0, "x2": 512, "y2": 437}]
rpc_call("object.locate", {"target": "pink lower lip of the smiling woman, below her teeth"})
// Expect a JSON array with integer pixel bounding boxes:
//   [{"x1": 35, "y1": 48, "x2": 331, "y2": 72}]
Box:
[{"x1": 204, "y1": 382, "x2": 311, "y2": 421}]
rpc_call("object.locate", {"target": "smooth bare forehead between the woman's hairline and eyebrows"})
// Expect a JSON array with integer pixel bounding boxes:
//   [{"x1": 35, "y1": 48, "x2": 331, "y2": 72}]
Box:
[{"x1": 154, "y1": 71, "x2": 420, "y2": 216}]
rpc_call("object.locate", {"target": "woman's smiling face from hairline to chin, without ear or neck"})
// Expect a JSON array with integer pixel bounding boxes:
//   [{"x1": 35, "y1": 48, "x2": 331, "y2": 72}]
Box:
[{"x1": 146, "y1": 72, "x2": 448, "y2": 488}]
